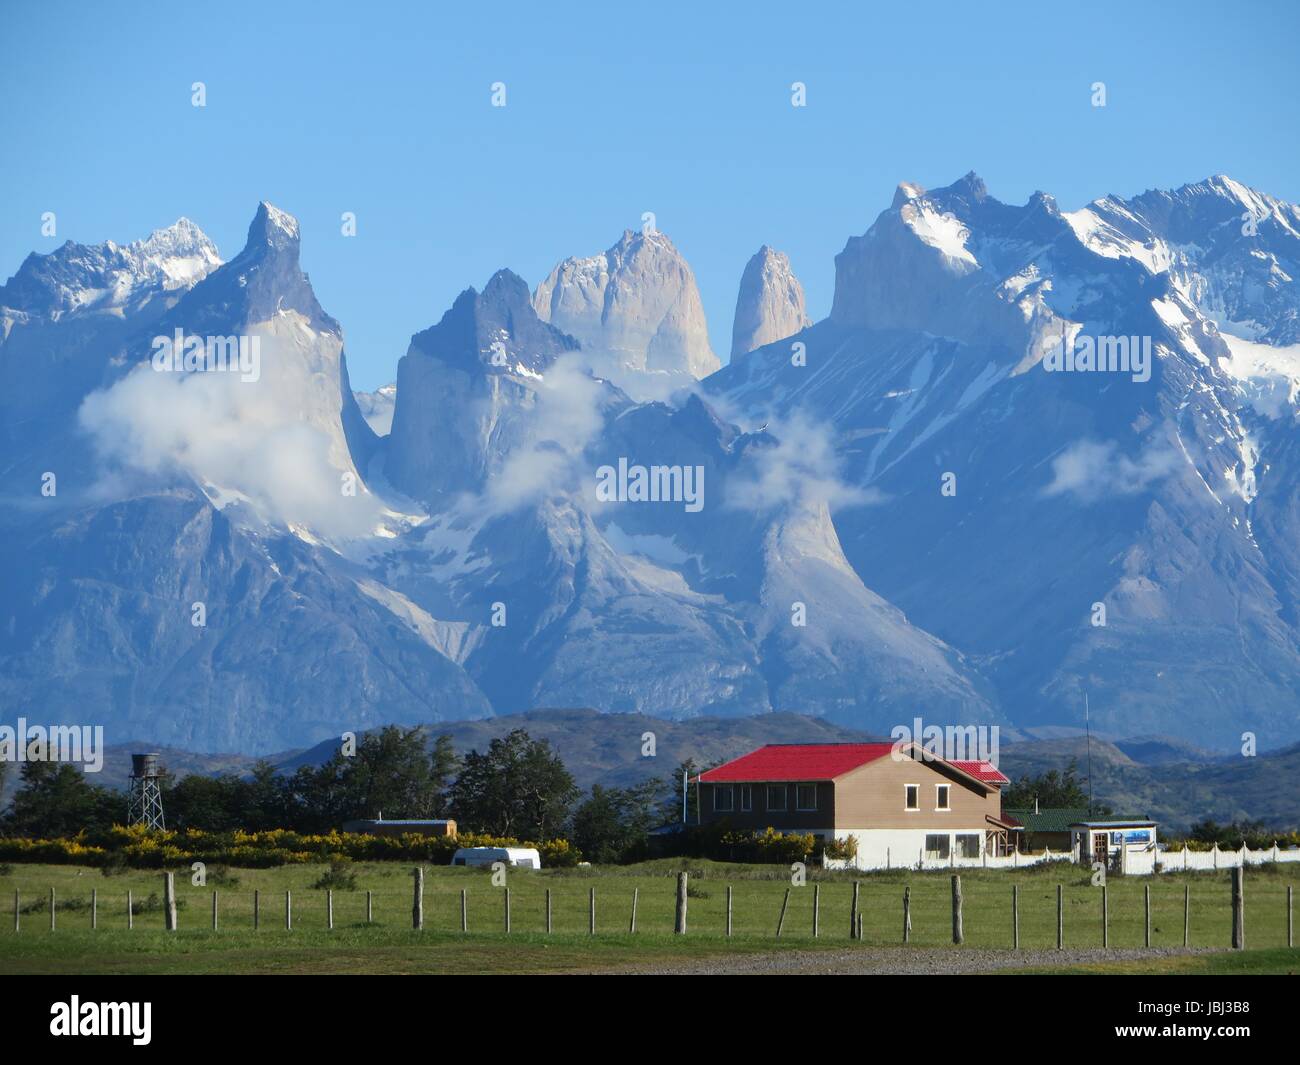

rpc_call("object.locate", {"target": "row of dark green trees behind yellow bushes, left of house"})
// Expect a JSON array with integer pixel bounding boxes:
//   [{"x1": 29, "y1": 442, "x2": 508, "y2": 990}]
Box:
[{"x1": 0, "y1": 726, "x2": 699, "y2": 862}]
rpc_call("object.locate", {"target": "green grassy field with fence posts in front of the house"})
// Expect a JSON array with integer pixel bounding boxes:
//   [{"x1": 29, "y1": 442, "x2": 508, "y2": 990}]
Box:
[{"x1": 0, "y1": 860, "x2": 1300, "y2": 973}]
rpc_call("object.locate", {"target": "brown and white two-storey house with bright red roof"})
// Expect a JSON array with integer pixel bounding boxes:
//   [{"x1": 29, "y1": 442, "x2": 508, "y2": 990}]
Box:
[{"x1": 698, "y1": 743, "x2": 1019, "y2": 869}]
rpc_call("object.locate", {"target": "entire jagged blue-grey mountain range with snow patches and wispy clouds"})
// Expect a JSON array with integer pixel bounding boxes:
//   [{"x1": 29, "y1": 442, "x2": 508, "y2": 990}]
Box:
[{"x1": 0, "y1": 174, "x2": 1300, "y2": 754}]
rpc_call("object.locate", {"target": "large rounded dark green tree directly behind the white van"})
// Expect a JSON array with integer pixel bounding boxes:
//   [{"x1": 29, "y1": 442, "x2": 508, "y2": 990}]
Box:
[{"x1": 447, "y1": 728, "x2": 579, "y2": 840}]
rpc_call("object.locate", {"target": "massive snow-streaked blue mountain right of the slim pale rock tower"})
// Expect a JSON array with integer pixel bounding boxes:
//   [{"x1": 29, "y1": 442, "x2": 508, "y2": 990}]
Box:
[{"x1": 706, "y1": 176, "x2": 1300, "y2": 743}]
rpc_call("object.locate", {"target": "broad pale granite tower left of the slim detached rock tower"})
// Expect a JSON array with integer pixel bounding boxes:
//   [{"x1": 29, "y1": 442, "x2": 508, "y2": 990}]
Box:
[{"x1": 533, "y1": 230, "x2": 719, "y2": 398}]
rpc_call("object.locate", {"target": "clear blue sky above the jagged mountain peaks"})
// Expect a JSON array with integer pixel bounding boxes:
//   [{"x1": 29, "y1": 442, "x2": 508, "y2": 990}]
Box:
[{"x1": 0, "y1": 0, "x2": 1300, "y2": 388}]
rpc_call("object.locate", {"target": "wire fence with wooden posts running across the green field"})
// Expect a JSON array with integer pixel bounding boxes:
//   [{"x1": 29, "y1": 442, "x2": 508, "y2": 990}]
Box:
[{"x1": 10, "y1": 874, "x2": 1295, "y2": 948}]
